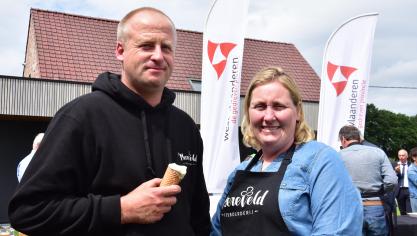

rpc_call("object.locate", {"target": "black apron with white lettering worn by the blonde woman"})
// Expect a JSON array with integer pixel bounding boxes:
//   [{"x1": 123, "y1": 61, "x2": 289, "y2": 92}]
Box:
[{"x1": 220, "y1": 145, "x2": 295, "y2": 236}]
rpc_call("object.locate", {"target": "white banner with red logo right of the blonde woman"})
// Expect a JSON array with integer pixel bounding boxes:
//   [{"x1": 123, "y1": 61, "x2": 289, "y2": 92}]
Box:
[{"x1": 317, "y1": 13, "x2": 378, "y2": 150}]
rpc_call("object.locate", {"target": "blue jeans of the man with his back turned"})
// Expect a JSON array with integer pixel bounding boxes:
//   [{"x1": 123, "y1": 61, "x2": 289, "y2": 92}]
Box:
[{"x1": 362, "y1": 206, "x2": 388, "y2": 236}]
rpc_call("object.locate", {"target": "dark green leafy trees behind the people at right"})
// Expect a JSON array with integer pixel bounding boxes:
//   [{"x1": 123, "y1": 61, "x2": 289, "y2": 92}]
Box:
[{"x1": 365, "y1": 104, "x2": 417, "y2": 159}]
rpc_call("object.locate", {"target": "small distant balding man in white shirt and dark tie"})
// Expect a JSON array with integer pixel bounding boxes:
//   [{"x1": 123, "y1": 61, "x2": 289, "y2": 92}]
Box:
[{"x1": 395, "y1": 149, "x2": 411, "y2": 215}]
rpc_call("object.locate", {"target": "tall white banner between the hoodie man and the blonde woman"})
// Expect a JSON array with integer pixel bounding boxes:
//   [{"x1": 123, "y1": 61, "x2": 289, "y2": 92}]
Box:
[{"x1": 200, "y1": 0, "x2": 249, "y2": 194}]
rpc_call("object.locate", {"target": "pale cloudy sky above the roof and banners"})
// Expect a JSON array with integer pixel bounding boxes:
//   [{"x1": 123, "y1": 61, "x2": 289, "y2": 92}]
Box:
[{"x1": 0, "y1": 0, "x2": 417, "y2": 116}]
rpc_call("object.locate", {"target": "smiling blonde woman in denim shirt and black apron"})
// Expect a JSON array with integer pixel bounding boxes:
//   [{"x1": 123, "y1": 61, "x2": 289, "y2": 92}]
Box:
[{"x1": 211, "y1": 67, "x2": 363, "y2": 236}]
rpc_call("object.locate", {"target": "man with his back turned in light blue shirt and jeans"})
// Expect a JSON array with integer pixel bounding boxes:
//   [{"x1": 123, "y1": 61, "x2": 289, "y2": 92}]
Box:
[{"x1": 339, "y1": 126, "x2": 397, "y2": 235}]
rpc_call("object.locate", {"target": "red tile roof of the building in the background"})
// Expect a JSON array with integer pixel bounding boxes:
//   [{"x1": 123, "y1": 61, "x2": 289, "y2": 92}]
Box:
[{"x1": 26, "y1": 9, "x2": 320, "y2": 102}]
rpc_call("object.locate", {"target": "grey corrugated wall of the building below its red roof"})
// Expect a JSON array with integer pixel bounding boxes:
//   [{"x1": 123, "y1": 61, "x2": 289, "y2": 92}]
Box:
[{"x1": 0, "y1": 76, "x2": 319, "y2": 130}]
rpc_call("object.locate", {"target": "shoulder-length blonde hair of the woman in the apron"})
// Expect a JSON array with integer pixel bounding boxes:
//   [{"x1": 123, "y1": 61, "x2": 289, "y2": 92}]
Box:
[{"x1": 241, "y1": 67, "x2": 314, "y2": 150}]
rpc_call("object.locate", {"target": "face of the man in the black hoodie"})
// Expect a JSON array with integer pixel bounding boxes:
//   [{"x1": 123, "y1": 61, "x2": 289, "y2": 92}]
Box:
[{"x1": 116, "y1": 12, "x2": 176, "y2": 94}]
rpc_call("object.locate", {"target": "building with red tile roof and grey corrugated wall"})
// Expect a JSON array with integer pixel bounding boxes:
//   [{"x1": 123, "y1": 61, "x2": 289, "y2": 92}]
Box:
[{"x1": 0, "y1": 9, "x2": 320, "y2": 223}]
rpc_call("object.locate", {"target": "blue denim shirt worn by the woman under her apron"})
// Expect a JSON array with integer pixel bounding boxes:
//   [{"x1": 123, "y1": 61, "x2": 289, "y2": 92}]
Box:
[{"x1": 211, "y1": 141, "x2": 363, "y2": 236}]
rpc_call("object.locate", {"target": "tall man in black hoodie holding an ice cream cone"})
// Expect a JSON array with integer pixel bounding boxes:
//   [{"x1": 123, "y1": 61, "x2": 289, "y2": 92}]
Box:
[{"x1": 9, "y1": 8, "x2": 210, "y2": 235}]
